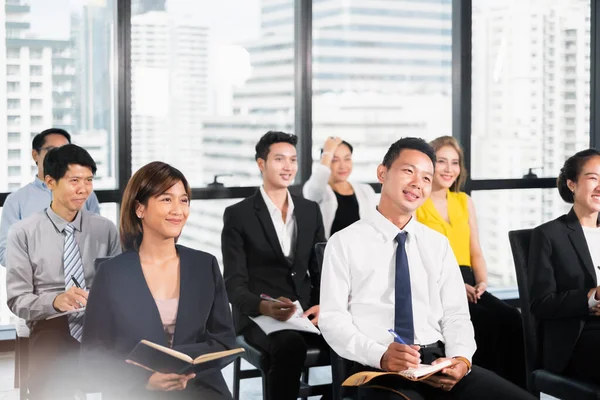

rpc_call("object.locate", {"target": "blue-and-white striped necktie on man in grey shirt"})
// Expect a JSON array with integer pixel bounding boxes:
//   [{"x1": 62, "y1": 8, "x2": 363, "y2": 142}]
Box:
[{"x1": 63, "y1": 225, "x2": 85, "y2": 342}]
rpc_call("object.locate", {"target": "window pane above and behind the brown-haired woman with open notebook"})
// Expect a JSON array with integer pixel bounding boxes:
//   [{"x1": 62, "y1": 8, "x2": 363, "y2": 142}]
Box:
[{"x1": 131, "y1": 0, "x2": 294, "y2": 187}]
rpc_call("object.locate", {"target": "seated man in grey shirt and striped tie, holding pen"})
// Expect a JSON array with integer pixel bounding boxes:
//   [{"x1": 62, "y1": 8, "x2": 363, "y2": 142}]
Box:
[{"x1": 6, "y1": 144, "x2": 120, "y2": 400}]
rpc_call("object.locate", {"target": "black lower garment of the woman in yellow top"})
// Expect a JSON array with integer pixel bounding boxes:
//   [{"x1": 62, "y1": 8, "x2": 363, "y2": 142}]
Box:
[{"x1": 460, "y1": 266, "x2": 526, "y2": 388}]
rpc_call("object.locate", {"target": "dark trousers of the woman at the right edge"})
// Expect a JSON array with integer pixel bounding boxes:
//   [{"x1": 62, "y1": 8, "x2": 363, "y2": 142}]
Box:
[{"x1": 564, "y1": 317, "x2": 600, "y2": 385}]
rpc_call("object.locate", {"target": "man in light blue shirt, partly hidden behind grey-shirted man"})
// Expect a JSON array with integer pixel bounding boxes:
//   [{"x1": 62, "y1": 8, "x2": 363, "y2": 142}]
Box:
[{"x1": 0, "y1": 128, "x2": 100, "y2": 266}]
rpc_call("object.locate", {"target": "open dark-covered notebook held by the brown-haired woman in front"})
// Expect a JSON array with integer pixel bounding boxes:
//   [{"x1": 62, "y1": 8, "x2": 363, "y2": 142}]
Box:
[{"x1": 126, "y1": 340, "x2": 244, "y2": 374}]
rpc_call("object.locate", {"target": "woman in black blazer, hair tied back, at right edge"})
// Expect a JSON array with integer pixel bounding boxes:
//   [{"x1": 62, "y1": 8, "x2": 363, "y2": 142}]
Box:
[{"x1": 529, "y1": 149, "x2": 600, "y2": 384}]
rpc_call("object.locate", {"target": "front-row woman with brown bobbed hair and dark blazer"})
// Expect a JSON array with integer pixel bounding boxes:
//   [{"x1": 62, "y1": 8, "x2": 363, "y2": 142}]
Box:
[{"x1": 81, "y1": 161, "x2": 235, "y2": 400}]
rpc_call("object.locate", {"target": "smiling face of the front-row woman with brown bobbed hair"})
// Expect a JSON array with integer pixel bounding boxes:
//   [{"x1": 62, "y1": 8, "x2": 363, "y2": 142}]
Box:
[{"x1": 136, "y1": 181, "x2": 190, "y2": 239}]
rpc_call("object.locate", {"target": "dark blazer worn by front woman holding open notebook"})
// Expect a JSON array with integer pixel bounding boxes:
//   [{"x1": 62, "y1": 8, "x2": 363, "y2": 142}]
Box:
[{"x1": 81, "y1": 245, "x2": 236, "y2": 398}]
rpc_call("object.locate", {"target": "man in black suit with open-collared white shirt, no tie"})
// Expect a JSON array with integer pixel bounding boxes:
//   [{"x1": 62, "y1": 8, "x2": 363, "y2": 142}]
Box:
[{"x1": 222, "y1": 132, "x2": 327, "y2": 400}]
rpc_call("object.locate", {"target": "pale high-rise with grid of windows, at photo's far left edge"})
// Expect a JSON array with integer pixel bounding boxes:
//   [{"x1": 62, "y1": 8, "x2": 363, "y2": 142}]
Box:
[{"x1": 1, "y1": 0, "x2": 76, "y2": 191}]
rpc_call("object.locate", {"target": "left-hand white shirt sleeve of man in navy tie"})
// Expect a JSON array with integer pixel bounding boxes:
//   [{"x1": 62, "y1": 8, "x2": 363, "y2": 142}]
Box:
[{"x1": 319, "y1": 235, "x2": 387, "y2": 369}]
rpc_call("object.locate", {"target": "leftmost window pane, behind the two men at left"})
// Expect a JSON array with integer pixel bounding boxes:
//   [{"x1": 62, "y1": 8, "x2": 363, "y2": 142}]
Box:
[{"x1": 0, "y1": 0, "x2": 118, "y2": 192}]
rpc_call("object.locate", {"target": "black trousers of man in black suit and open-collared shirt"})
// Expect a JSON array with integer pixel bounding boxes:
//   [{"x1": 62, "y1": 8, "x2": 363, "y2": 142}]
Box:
[{"x1": 242, "y1": 323, "x2": 329, "y2": 400}]
